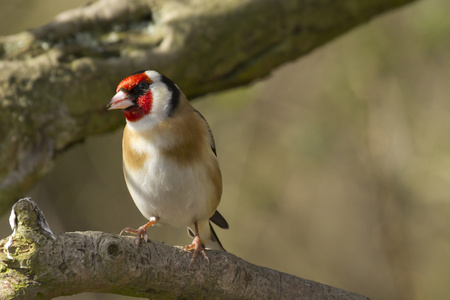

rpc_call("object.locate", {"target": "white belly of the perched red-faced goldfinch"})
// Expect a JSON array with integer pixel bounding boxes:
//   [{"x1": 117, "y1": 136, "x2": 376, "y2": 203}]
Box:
[{"x1": 124, "y1": 151, "x2": 218, "y2": 226}]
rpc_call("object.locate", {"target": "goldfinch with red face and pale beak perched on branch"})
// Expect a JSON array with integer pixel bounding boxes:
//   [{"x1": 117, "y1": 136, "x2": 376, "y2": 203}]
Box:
[{"x1": 107, "y1": 70, "x2": 229, "y2": 263}]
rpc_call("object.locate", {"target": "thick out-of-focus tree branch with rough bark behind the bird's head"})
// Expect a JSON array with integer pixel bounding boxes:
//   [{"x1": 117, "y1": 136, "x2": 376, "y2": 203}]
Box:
[{"x1": 0, "y1": 0, "x2": 413, "y2": 213}]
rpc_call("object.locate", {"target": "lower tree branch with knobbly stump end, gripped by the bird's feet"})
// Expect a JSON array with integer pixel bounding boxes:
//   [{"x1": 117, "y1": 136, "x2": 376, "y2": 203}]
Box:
[{"x1": 0, "y1": 198, "x2": 368, "y2": 300}]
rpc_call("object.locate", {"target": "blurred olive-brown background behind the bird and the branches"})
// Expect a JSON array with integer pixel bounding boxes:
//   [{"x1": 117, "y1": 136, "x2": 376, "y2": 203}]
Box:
[{"x1": 0, "y1": 0, "x2": 450, "y2": 300}]
